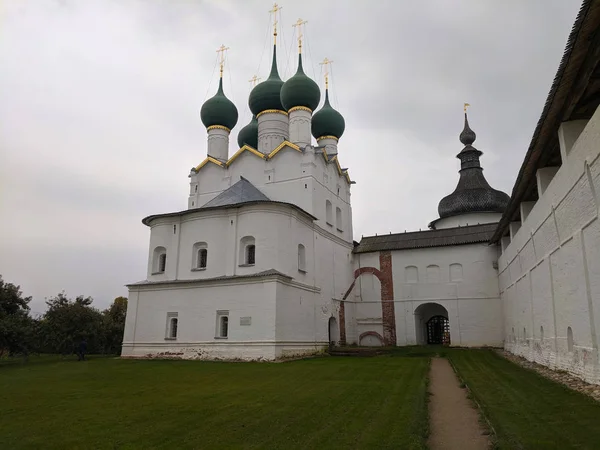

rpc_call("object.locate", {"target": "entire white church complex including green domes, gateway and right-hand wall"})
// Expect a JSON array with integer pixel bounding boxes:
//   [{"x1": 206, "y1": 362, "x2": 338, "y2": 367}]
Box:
[{"x1": 122, "y1": 0, "x2": 600, "y2": 383}]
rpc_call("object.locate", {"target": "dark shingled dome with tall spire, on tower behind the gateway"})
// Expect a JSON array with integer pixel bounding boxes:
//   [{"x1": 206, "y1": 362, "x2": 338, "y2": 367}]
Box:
[{"x1": 438, "y1": 114, "x2": 510, "y2": 219}]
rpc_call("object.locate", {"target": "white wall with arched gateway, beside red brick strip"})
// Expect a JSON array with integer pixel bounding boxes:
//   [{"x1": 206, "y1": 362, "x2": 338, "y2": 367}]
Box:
[{"x1": 346, "y1": 244, "x2": 503, "y2": 347}]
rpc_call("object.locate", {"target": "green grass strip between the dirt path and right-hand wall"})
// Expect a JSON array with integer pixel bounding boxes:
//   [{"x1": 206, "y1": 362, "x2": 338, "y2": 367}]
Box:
[{"x1": 447, "y1": 349, "x2": 600, "y2": 449}]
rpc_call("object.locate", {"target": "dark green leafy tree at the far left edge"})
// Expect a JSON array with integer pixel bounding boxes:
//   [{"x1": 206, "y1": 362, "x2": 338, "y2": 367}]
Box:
[{"x1": 0, "y1": 275, "x2": 35, "y2": 356}]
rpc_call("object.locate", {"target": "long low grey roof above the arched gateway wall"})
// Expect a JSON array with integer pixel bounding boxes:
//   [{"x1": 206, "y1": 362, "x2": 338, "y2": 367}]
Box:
[{"x1": 354, "y1": 223, "x2": 498, "y2": 253}]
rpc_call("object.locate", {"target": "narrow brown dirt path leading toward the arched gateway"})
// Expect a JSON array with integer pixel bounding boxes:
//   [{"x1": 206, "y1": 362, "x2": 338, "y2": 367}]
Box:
[{"x1": 429, "y1": 358, "x2": 490, "y2": 450}]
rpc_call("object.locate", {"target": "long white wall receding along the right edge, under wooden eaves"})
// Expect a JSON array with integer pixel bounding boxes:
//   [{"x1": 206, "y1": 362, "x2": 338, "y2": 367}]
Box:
[{"x1": 499, "y1": 104, "x2": 600, "y2": 383}]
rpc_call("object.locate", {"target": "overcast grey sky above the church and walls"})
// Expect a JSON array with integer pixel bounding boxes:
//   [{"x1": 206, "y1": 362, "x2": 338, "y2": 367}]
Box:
[{"x1": 0, "y1": 0, "x2": 580, "y2": 312}]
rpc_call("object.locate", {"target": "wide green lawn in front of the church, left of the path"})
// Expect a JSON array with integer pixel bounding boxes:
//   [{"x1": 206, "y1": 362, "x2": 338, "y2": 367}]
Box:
[{"x1": 0, "y1": 356, "x2": 429, "y2": 449}]
